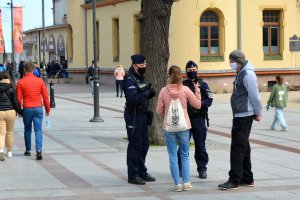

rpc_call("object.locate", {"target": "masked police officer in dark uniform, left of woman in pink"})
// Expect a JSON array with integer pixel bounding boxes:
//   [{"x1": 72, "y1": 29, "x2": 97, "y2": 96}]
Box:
[{"x1": 122, "y1": 54, "x2": 156, "y2": 185}]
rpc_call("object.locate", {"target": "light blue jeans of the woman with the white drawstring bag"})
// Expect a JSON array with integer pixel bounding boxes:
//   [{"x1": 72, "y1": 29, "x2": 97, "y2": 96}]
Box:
[{"x1": 164, "y1": 130, "x2": 190, "y2": 185}]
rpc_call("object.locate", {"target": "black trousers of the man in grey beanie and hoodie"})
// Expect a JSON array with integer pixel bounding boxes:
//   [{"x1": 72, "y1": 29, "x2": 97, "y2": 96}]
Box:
[{"x1": 229, "y1": 116, "x2": 254, "y2": 184}]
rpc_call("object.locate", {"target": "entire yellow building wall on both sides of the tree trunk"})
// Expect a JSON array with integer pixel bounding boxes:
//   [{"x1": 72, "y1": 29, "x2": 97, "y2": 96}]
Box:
[{"x1": 68, "y1": 0, "x2": 300, "y2": 70}]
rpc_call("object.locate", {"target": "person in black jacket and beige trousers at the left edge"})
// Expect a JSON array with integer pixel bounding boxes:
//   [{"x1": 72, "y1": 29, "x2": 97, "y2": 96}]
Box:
[{"x1": 0, "y1": 72, "x2": 23, "y2": 161}]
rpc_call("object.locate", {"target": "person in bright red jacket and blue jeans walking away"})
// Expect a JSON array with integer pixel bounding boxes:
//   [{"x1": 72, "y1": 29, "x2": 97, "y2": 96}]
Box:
[{"x1": 17, "y1": 62, "x2": 50, "y2": 160}]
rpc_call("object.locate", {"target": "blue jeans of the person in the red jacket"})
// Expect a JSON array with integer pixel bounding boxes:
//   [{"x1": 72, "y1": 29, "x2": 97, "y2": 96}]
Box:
[{"x1": 23, "y1": 107, "x2": 43, "y2": 152}]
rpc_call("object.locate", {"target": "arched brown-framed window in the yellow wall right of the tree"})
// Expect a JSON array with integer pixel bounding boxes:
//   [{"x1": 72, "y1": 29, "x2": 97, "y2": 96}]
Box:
[{"x1": 200, "y1": 11, "x2": 220, "y2": 56}]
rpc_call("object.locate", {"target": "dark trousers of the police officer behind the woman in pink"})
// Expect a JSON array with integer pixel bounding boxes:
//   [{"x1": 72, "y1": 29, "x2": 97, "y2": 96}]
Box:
[{"x1": 177, "y1": 117, "x2": 208, "y2": 172}]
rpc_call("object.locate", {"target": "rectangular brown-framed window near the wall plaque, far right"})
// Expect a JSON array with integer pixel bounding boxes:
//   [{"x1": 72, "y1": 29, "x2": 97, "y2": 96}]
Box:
[{"x1": 263, "y1": 10, "x2": 280, "y2": 55}]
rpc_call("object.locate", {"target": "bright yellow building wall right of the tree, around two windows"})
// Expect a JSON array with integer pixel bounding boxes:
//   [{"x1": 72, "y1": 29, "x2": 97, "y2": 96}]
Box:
[{"x1": 169, "y1": 0, "x2": 300, "y2": 70}]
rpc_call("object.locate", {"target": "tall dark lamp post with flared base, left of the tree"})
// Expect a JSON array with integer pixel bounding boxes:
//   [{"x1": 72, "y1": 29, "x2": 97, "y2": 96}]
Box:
[{"x1": 90, "y1": 0, "x2": 104, "y2": 122}]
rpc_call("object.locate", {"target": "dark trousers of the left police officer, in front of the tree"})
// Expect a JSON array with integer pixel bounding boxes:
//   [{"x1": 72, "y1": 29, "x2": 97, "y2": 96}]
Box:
[{"x1": 124, "y1": 112, "x2": 149, "y2": 179}]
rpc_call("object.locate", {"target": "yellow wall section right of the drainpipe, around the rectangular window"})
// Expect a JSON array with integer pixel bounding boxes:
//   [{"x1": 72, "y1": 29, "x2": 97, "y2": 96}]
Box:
[{"x1": 242, "y1": 0, "x2": 300, "y2": 68}]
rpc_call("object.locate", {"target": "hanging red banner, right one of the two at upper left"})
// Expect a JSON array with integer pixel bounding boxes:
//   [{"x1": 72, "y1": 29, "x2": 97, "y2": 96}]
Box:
[{"x1": 14, "y1": 7, "x2": 23, "y2": 53}]
